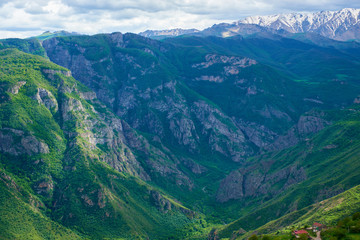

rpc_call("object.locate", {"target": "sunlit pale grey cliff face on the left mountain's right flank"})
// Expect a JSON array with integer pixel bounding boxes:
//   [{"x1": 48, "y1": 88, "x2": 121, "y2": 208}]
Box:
[{"x1": 60, "y1": 79, "x2": 150, "y2": 180}]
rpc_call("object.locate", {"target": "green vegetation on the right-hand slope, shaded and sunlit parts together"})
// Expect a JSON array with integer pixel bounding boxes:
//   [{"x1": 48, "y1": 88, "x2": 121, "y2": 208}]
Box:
[{"x1": 220, "y1": 106, "x2": 360, "y2": 236}]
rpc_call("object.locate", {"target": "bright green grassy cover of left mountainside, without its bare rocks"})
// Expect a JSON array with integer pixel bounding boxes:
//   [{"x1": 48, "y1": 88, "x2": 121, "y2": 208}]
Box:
[{"x1": 0, "y1": 49, "x2": 195, "y2": 239}]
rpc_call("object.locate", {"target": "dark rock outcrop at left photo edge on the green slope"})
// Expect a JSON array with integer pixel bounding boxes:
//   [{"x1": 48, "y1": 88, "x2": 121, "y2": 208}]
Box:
[{"x1": 0, "y1": 128, "x2": 49, "y2": 156}]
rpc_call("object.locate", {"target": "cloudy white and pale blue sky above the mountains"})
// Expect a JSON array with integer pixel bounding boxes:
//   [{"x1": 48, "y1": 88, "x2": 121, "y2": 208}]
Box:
[{"x1": 0, "y1": 0, "x2": 360, "y2": 39}]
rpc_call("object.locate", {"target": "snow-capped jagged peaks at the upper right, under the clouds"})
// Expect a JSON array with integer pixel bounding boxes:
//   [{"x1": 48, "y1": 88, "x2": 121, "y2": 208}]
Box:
[{"x1": 238, "y1": 8, "x2": 360, "y2": 41}]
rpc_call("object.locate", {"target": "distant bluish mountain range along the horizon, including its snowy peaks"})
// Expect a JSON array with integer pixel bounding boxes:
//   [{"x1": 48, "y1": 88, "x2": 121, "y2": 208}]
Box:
[{"x1": 140, "y1": 8, "x2": 360, "y2": 41}]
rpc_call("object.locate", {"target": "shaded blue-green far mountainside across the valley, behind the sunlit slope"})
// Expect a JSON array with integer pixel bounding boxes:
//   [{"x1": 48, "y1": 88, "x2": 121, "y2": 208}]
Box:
[{"x1": 43, "y1": 33, "x2": 360, "y2": 221}]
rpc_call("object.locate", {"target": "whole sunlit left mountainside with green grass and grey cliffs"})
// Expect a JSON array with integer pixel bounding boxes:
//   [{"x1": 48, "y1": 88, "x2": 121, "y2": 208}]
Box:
[{"x1": 0, "y1": 49, "x2": 193, "y2": 239}]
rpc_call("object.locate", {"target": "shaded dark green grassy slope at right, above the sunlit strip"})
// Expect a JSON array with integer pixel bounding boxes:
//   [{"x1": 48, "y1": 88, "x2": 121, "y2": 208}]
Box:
[{"x1": 221, "y1": 106, "x2": 360, "y2": 236}]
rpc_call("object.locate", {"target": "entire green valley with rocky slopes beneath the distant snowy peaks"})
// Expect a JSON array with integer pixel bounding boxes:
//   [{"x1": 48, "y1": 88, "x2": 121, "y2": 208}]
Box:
[{"x1": 0, "y1": 6, "x2": 360, "y2": 239}]
